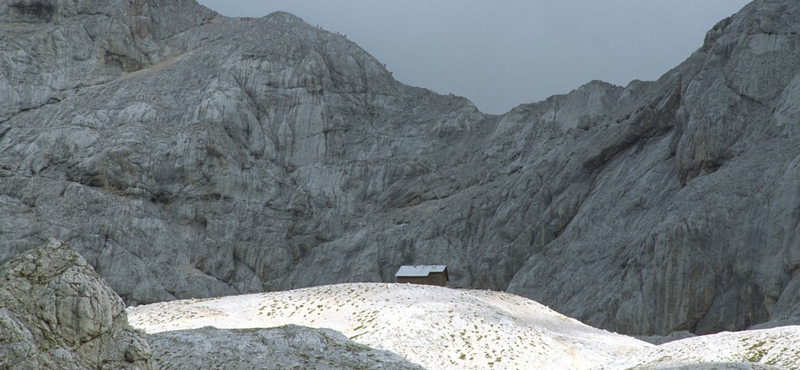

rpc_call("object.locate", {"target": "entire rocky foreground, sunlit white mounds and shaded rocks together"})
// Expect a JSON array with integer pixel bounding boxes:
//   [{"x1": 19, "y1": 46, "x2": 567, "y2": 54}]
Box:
[{"x1": 0, "y1": 240, "x2": 800, "y2": 370}]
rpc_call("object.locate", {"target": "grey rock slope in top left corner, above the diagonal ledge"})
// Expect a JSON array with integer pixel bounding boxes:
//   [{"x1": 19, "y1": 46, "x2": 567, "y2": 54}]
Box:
[{"x1": 0, "y1": 0, "x2": 216, "y2": 121}]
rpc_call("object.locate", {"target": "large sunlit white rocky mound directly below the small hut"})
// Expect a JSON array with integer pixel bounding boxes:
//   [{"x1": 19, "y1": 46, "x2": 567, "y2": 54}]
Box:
[{"x1": 128, "y1": 283, "x2": 652, "y2": 369}]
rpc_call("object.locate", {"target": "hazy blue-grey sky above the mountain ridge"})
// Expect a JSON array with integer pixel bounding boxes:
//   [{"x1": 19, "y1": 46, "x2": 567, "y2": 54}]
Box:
[{"x1": 192, "y1": 0, "x2": 750, "y2": 114}]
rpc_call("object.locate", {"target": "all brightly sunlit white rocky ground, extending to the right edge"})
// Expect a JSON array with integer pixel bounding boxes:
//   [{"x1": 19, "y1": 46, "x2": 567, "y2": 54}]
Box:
[{"x1": 128, "y1": 284, "x2": 800, "y2": 370}]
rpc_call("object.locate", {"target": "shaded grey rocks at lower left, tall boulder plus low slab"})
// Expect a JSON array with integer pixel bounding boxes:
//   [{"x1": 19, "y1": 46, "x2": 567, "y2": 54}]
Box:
[{"x1": 0, "y1": 240, "x2": 422, "y2": 370}]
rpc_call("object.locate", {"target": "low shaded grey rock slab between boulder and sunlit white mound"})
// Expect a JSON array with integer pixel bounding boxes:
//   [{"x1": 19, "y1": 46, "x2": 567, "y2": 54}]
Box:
[{"x1": 148, "y1": 325, "x2": 424, "y2": 370}]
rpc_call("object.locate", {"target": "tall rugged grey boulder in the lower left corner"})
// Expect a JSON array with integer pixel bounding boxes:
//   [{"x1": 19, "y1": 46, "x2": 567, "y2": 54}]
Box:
[{"x1": 0, "y1": 241, "x2": 152, "y2": 370}]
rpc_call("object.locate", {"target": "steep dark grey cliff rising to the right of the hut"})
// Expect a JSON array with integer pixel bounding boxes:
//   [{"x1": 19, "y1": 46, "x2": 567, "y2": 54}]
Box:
[{"x1": 509, "y1": 1, "x2": 800, "y2": 334}]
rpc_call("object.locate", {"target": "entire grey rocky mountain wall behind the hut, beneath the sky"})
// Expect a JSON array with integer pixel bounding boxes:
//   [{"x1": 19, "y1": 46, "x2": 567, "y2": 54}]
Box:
[{"x1": 0, "y1": 0, "x2": 800, "y2": 334}]
